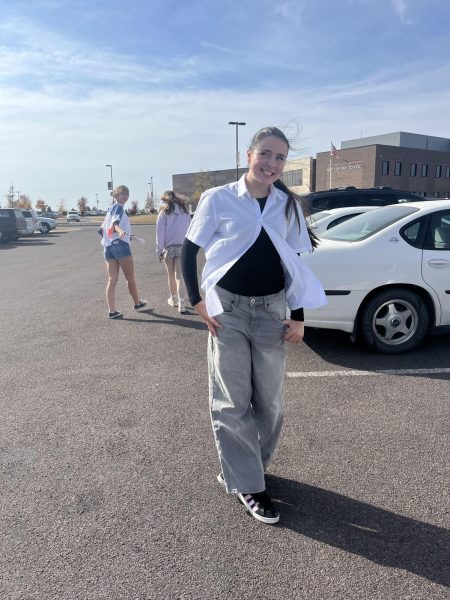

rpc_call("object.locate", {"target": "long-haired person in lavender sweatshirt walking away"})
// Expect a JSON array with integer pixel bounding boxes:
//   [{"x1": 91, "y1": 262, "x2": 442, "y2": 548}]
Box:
[{"x1": 156, "y1": 190, "x2": 191, "y2": 314}]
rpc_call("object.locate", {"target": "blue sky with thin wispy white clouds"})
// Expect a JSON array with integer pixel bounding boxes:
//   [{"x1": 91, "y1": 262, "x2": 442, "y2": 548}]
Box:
[{"x1": 0, "y1": 0, "x2": 450, "y2": 210}]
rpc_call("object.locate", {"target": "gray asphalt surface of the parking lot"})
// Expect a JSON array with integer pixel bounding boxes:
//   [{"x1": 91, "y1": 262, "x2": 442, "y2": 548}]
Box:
[{"x1": 0, "y1": 221, "x2": 450, "y2": 600}]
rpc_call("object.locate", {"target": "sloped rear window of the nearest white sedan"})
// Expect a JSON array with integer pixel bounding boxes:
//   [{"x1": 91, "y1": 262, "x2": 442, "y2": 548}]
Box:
[{"x1": 320, "y1": 205, "x2": 419, "y2": 242}]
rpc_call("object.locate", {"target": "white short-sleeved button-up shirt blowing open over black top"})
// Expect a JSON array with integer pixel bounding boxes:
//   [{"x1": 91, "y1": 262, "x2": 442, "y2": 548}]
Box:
[{"x1": 186, "y1": 175, "x2": 327, "y2": 317}]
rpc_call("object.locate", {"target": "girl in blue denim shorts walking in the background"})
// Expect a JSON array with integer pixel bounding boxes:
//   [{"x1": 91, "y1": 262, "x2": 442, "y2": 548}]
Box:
[{"x1": 101, "y1": 185, "x2": 147, "y2": 319}]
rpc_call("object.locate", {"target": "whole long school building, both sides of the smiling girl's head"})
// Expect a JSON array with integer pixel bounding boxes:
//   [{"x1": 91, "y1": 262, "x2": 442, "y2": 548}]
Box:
[{"x1": 172, "y1": 131, "x2": 450, "y2": 202}]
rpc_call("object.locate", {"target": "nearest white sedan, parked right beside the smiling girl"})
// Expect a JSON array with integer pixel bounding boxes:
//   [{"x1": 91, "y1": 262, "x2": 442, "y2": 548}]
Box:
[{"x1": 303, "y1": 200, "x2": 450, "y2": 354}]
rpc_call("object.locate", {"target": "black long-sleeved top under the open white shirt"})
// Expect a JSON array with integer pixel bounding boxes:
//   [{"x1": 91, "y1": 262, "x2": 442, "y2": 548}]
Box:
[{"x1": 181, "y1": 197, "x2": 304, "y2": 321}]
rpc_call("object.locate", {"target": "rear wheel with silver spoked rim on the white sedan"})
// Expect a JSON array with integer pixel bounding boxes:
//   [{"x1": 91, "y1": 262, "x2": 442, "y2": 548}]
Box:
[{"x1": 360, "y1": 288, "x2": 430, "y2": 354}]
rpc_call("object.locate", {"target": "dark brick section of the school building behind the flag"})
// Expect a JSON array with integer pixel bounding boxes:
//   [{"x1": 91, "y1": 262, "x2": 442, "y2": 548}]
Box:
[{"x1": 316, "y1": 131, "x2": 450, "y2": 198}]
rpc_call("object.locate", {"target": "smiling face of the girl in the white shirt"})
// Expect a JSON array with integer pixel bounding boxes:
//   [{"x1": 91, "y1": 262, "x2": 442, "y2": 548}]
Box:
[{"x1": 246, "y1": 135, "x2": 289, "y2": 198}]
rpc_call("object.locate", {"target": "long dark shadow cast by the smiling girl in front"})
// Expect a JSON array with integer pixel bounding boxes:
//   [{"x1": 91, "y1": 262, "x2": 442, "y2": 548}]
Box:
[{"x1": 266, "y1": 475, "x2": 450, "y2": 586}]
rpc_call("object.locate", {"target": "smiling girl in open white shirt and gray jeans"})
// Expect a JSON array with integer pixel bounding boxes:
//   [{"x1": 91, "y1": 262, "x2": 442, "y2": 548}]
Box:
[{"x1": 182, "y1": 127, "x2": 326, "y2": 523}]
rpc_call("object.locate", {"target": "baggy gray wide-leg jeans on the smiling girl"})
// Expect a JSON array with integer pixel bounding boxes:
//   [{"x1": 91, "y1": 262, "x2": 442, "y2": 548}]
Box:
[{"x1": 208, "y1": 287, "x2": 286, "y2": 493}]
